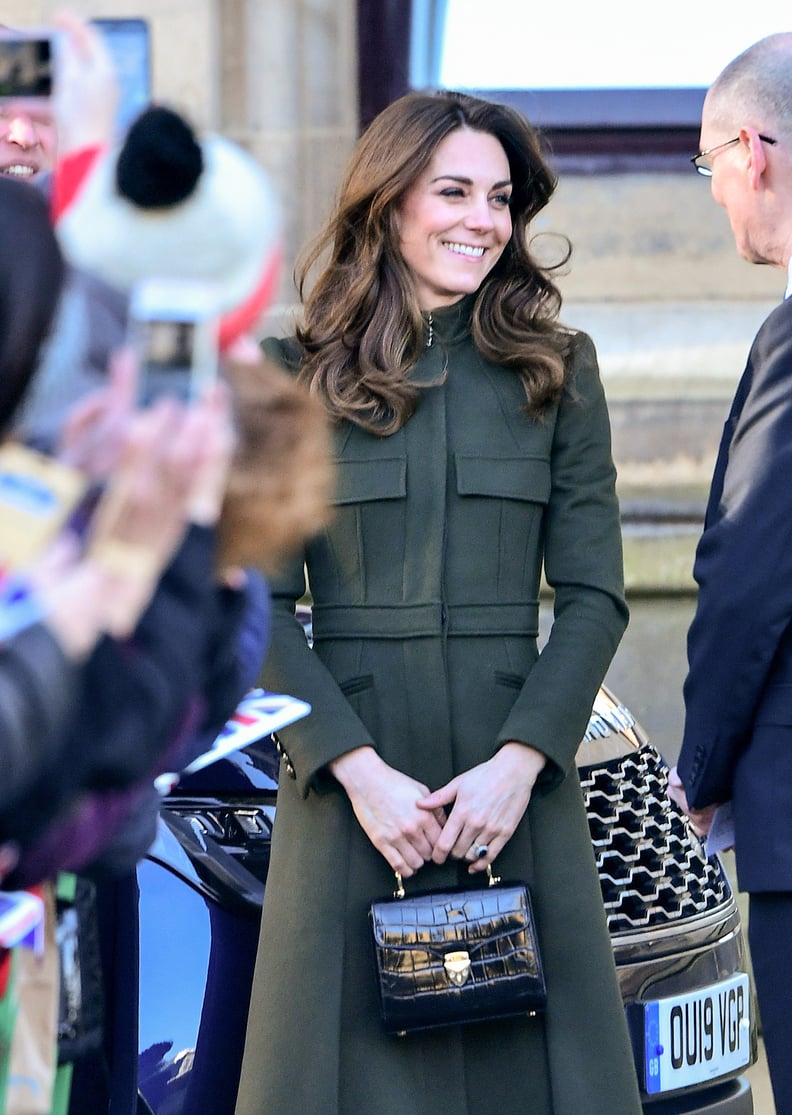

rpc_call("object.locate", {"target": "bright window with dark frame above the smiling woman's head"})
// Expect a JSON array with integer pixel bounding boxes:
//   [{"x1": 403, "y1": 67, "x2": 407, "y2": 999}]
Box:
[{"x1": 358, "y1": 0, "x2": 789, "y2": 172}]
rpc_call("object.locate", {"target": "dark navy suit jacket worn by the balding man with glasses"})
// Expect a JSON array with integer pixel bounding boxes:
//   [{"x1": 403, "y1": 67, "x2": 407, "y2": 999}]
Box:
[{"x1": 678, "y1": 300, "x2": 792, "y2": 891}]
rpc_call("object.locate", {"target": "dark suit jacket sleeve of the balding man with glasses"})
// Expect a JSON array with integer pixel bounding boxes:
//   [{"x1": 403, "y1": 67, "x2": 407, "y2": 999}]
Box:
[{"x1": 678, "y1": 303, "x2": 792, "y2": 807}]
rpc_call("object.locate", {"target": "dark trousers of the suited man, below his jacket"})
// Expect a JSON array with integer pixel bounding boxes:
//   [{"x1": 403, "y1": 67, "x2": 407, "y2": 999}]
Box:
[{"x1": 748, "y1": 892, "x2": 792, "y2": 1115}]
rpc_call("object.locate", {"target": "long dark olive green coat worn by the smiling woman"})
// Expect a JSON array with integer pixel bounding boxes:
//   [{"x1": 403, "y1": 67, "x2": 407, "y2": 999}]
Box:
[{"x1": 238, "y1": 298, "x2": 640, "y2": 1115}]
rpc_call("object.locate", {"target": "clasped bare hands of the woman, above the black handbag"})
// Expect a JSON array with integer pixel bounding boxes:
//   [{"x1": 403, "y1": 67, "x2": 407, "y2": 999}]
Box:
[{"x1": 330, "y1": 741, "x2": 547, "y2": 879}]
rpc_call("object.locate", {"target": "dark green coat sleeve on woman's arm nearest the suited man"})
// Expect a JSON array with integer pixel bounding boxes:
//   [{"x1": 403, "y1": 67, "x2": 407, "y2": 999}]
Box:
[{"x1": 498, "y1": 333, "x2": 628, "y2": 789}]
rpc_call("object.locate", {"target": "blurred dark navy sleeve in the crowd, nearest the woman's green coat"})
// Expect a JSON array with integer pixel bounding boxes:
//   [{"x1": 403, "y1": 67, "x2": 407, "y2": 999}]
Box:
[{"x1": 0, "y1": 526, "x2": 250, "y2": 846}]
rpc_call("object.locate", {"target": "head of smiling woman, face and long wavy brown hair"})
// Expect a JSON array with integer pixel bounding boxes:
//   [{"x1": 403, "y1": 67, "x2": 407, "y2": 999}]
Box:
[{"x1": 285, "y1": 93, "x2": 569, "y2": 436}]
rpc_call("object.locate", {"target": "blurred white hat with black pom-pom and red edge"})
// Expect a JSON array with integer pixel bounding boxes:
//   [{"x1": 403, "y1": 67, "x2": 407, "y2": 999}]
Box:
[{"x1": 56, "y1": 108, "x2": 281, "y2": 343}]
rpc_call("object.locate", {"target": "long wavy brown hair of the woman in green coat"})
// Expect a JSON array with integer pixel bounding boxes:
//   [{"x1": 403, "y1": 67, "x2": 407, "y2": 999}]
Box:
[{"x1": 297, "y1": 91, "x2": 570, "y2": 436}]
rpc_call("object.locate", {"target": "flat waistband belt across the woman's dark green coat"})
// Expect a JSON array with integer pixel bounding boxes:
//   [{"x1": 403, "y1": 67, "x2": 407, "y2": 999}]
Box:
[{"x1": 313, "y1": 602, "x2": 539, "y2": 639}]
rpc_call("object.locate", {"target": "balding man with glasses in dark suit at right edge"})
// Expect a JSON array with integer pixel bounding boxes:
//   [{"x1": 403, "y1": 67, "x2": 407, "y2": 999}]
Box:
[{"x1": 670, "y1": 32, "x2": 792, "y2": 1115}]
